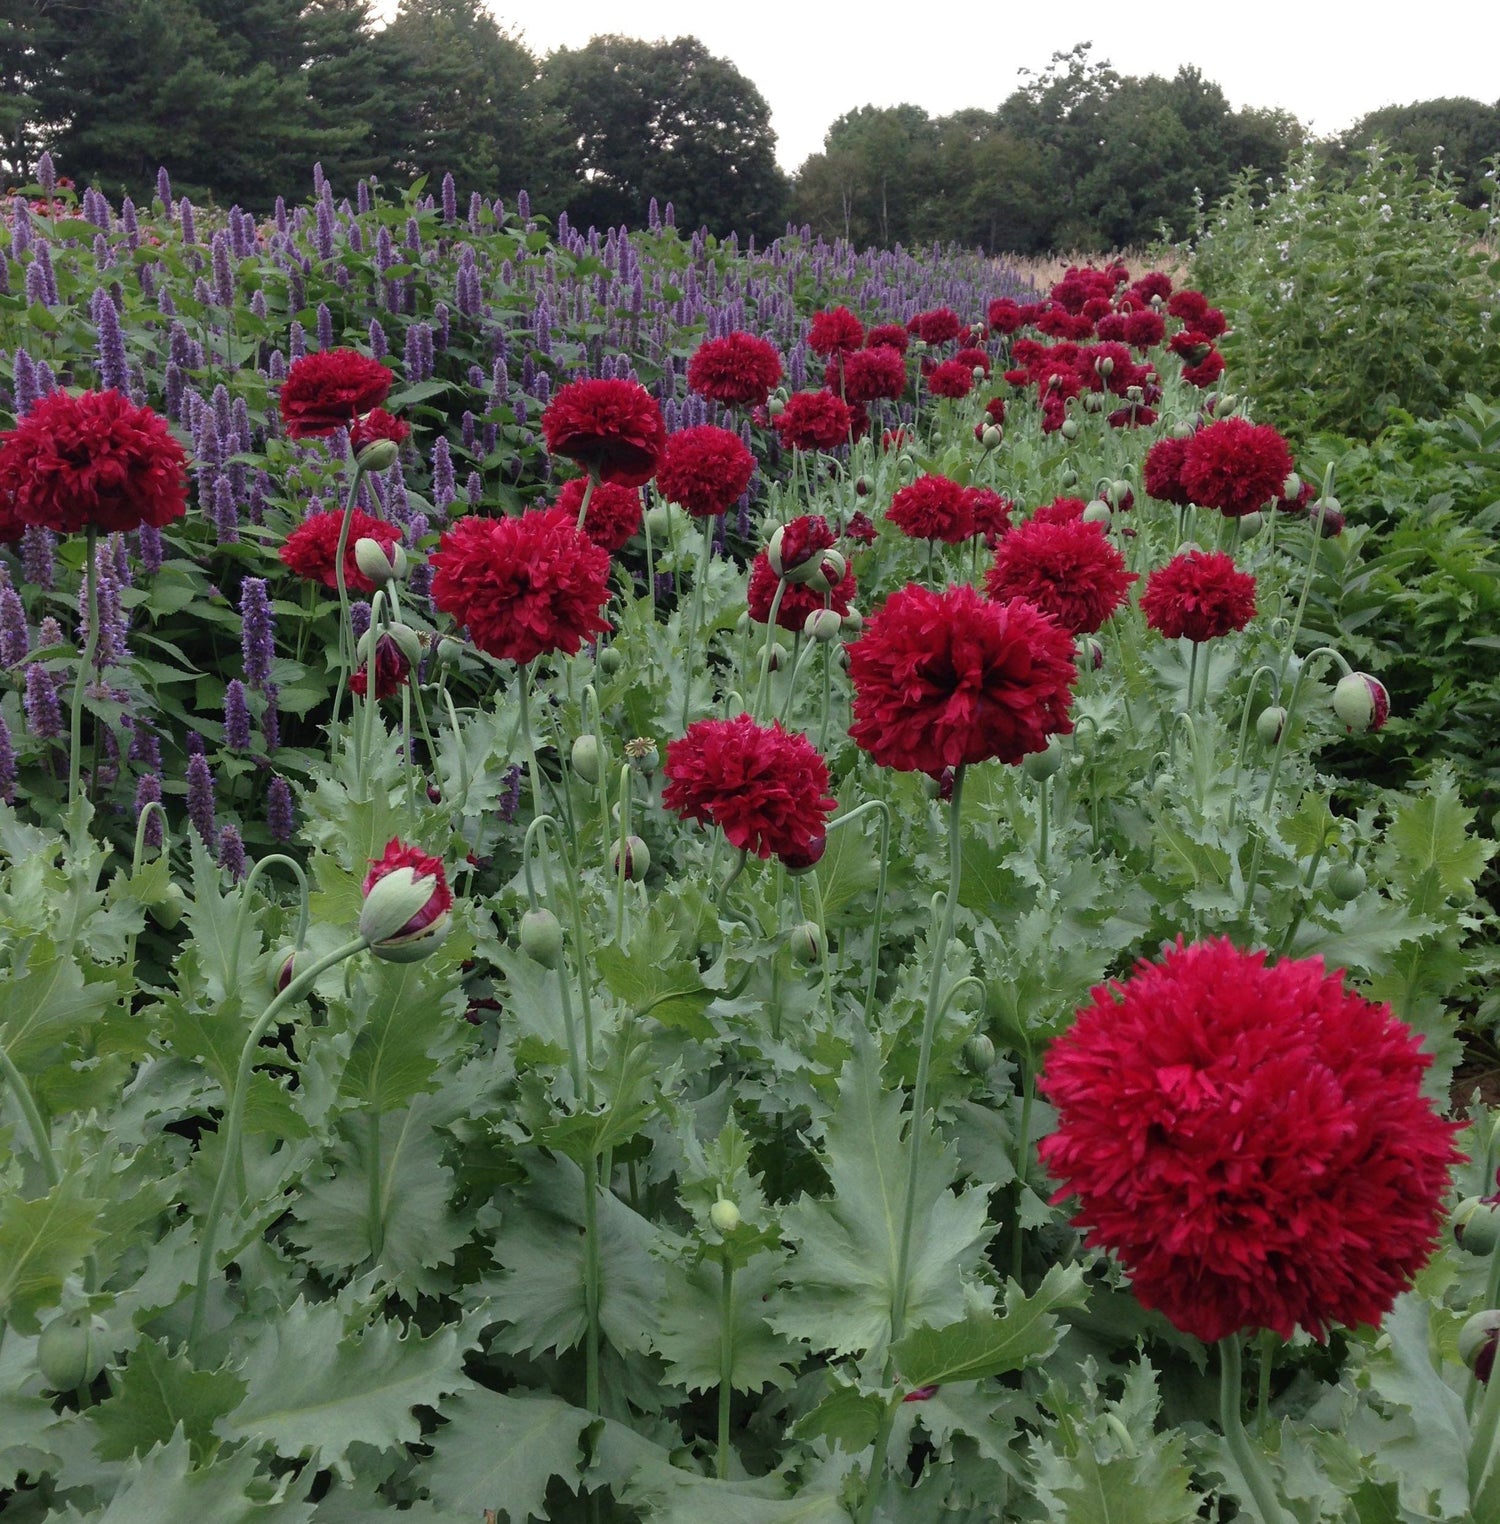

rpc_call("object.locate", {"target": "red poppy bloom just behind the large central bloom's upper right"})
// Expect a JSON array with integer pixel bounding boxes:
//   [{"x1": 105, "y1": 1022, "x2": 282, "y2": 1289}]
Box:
[{"x1": 985, "y1": 515, "x2": 1136, "y2": 636}]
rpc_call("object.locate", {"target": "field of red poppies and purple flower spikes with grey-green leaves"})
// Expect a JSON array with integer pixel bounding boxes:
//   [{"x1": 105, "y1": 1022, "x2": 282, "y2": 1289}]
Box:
[{"x1": 0, "y1": 166, "x2": 1500, "y2": 1524}]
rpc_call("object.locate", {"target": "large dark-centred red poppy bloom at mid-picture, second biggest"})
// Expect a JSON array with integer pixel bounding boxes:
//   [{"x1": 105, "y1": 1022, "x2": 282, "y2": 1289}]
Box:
[{"x1": 848, "y1": 582, "x2": 1078, "y2": 776}]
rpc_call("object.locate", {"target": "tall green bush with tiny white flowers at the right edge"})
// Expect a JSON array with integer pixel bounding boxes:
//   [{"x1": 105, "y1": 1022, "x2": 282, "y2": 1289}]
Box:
[{"x1": 1192, "y1": 148, "x2": 1500, "y2": 440}]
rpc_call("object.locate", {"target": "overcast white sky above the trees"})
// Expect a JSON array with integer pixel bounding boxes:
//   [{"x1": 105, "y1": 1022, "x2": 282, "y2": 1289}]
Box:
[{"x1": 377, "y1": 0, "x2": 1500, "y2": 169}]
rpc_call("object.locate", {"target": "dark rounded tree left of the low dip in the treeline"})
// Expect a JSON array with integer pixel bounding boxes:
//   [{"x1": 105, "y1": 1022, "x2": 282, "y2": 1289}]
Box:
[{"x1": 541, "y1": 37, "x2": 787, "y2": 236}]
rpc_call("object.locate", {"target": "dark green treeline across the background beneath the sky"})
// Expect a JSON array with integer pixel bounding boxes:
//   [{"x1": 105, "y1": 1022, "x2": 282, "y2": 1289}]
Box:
[{"x1": 0, "y1": 0, "x2": 1500, "y2": 253}]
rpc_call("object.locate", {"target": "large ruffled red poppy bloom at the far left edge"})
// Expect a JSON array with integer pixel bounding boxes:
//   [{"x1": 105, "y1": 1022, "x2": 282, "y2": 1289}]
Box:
[{"x1": 0, "y1": 389, "x2": 188, "y2": 539}]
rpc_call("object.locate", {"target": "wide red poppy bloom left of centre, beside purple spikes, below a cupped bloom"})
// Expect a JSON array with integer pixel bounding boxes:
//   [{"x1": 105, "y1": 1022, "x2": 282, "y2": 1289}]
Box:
[{"x1": 428, "y1": 507, "x2": 610, "y2": 663}]
